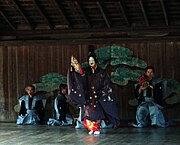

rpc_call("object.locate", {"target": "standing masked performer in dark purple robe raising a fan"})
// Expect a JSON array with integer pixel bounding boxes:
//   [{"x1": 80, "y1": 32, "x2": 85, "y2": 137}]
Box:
[{"x1": 68, "y1": 49, "x2": 120, "y2": 135}]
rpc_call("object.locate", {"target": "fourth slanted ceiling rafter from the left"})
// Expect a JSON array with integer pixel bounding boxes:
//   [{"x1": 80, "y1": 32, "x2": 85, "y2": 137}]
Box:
[{"x1": 52, "y1": 0, "x2": 72, "y2": 28}]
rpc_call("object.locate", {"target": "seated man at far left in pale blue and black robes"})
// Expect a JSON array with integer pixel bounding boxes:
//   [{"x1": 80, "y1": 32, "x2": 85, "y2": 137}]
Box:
[{"x1": 16, "y1": 85, "x2": 46, "y2": 125}]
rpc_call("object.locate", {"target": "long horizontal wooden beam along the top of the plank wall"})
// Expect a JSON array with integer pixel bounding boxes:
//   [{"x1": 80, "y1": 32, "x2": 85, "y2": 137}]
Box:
[{"x1": 0, "y1": 36, "x2": 180, "y2": 43}]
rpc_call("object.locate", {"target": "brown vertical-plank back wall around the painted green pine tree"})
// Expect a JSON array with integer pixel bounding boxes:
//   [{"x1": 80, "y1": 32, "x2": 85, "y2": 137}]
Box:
[{"x1": 0, "y1": 40, "x2": 180, "y2": 121}]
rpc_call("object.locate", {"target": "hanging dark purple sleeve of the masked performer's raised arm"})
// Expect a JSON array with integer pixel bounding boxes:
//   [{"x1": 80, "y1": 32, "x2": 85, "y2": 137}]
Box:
[{"x1": 67, "y1": 70, "x2": 86, "y2": 105}]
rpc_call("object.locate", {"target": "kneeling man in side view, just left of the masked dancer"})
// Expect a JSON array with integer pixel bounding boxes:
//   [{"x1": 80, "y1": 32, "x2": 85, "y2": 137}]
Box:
[{"x1": 48, "y1": 84, "x2": 73, "y2": 126}]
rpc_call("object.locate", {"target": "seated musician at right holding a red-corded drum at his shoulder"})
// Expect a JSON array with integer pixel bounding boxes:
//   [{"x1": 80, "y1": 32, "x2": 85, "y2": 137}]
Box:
[{"x1": 133, "y1": 66, "x2": 167, "y2": 127}]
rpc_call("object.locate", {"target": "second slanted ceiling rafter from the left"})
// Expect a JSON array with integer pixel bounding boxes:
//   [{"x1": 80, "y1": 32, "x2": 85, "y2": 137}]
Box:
[{"x1": 12, "y1": 0, "x2": 34, "y2": 30}]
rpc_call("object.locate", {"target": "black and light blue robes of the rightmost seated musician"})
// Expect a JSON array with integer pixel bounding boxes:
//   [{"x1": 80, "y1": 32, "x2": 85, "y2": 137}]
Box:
[{"x1": 133, "y1": 80, "x2": 167, "y2": 127}]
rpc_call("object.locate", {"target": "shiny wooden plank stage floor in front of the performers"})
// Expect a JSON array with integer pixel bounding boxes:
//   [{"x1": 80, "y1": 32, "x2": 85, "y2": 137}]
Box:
[{"x1": 0, "y1": 123, "x2": 180, "y2": 145}]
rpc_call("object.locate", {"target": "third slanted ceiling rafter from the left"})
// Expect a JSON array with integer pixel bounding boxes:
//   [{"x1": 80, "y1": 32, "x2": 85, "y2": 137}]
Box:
[{"x1": 32, "y1": 0, "x2": 54, "y2": 30}]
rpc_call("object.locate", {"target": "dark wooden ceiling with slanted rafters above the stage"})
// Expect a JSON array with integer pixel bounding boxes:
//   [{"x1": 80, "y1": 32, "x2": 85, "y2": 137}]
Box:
[{"x1": 0, "y1": 0, "x2": 180, "y2": 41}]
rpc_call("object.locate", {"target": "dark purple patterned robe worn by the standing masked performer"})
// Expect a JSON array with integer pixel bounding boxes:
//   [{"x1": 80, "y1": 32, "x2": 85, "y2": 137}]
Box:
[{"x1": 67, "y1": 67, "x2": 120, "y2": 126}]
